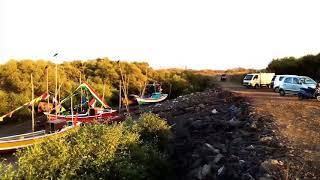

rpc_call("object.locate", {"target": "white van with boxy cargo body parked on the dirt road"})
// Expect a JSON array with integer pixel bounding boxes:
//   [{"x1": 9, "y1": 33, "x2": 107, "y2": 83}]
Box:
[{"x1": 242, "y1": 73, "x2": 274, "y2": 88}]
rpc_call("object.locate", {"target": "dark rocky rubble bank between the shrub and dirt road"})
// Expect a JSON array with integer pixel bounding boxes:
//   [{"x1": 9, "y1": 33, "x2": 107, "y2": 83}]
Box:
[{"x1": 137, "y1": 88, "x2": 288, "y2": 180}]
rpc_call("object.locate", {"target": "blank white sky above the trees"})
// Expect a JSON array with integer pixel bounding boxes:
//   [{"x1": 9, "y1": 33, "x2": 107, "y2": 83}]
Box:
[{"x1": 0, "y1": 0, "x2": 320, "y2": 69}]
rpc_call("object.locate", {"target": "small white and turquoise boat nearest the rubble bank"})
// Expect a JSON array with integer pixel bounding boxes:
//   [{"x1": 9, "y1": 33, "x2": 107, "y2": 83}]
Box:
[{"x1": 136, "y1": 83, "x2": 168, "y2": 105}]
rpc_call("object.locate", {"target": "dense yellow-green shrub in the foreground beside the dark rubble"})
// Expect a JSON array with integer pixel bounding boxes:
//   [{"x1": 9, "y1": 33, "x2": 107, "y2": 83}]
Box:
[{"x1": 0, "y1": 114, "x2": 171, "y2": 179}]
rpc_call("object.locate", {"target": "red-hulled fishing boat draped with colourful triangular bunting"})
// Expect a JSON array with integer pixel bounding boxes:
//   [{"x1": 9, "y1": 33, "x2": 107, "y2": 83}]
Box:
[{"x1": 44, "y1": 82, "x2": 121, "y2": 123}]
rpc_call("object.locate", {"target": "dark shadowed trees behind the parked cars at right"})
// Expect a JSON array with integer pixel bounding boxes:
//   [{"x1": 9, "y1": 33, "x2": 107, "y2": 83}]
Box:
[{"x1": 267, "y1": 53, "x2": 320, "y2": 81}]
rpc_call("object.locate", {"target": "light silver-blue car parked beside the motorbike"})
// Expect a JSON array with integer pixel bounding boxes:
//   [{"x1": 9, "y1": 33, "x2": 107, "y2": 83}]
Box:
[{"x1": 279, "y1": 76, "x2": 317, "y2": 96}]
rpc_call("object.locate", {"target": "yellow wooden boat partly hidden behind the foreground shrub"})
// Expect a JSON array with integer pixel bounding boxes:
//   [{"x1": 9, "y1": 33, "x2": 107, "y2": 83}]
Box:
[{"x1": 0, "y1": 121, "x2": 81, "y2": 153}]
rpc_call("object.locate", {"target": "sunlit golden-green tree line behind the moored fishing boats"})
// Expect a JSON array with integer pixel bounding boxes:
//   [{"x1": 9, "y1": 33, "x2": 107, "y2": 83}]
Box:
[{"x1": 0, "y1": 58, "x2": 210, "y2": 118}]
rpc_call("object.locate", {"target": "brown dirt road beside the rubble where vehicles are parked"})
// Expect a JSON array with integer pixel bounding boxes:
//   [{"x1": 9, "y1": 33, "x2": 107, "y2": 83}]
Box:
[{"x1": 218, "y1": 82, "x2": 320, "y2": 178}]
